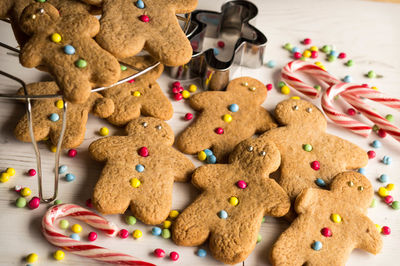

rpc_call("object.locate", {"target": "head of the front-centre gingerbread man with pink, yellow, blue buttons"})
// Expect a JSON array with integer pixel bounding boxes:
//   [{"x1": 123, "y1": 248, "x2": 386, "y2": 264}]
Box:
[{"x1": 229, "y1": 138, "x2": 281, "y2": 177}]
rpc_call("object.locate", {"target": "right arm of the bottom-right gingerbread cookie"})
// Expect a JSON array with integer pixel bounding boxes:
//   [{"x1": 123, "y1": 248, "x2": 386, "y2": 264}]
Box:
[{"x1": 356, "y1": 216, "x2": 383, "y2": 254}]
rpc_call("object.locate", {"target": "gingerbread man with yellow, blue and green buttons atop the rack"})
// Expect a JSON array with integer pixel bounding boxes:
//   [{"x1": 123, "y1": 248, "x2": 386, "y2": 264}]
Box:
[{"x1": 19, "y1": 3, "x2": 120, "y2": 103}]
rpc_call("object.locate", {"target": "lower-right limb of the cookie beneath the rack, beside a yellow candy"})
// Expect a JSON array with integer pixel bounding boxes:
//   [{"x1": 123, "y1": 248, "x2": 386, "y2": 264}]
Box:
[{"x1": 141, "y1": 82, "x2": 174, "y2": 120}]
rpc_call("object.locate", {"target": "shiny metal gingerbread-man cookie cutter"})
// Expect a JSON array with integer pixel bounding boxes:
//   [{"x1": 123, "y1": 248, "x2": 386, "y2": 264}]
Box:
[{"x1": 168, "y1": 1, "x2": 267, "y2": 90}]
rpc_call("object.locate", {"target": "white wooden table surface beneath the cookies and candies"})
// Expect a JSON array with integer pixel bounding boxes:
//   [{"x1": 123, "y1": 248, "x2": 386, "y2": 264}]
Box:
[{"x1": 0, "y1": 0, "x2": 400, "y2": 266}]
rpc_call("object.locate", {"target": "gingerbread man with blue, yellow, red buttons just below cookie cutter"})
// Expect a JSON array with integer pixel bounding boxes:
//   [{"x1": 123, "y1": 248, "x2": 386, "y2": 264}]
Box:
[{"x1": 177, "y1": 77, "x2": 276, "y2": 162}]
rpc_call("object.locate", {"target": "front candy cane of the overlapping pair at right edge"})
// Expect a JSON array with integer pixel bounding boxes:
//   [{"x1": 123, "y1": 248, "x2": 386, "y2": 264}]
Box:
[{"x1": 321, "y1": 83, "x2": 400, "y2": 141}]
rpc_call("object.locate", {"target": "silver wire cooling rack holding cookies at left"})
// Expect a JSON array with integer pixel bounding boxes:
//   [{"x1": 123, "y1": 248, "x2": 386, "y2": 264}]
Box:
[{"x1": 0, "y1": 14, "x2": 191, "y2": 203}]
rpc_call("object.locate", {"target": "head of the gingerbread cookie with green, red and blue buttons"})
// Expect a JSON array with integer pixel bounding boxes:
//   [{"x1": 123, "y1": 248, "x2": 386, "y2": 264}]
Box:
[{"x1": 275, "y1": 99, "x2": 327, "y2": 131}]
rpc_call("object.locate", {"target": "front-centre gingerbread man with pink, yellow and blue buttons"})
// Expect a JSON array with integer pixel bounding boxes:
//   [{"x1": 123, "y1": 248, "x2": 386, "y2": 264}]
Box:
[{"x1": 172, "y1": 139, "x2": 290, "y2": 264}]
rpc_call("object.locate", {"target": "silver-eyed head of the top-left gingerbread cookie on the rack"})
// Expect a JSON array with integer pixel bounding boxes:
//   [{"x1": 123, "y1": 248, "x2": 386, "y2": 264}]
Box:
[{"x1": 19, "y1": 2, "x2": 60, "y2": 35}]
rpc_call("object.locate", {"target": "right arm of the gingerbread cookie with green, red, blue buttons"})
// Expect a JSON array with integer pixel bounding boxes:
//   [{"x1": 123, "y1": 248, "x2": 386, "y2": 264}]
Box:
[{"x1": 326, "y1": 134, "x2": 368, "y2": 170}]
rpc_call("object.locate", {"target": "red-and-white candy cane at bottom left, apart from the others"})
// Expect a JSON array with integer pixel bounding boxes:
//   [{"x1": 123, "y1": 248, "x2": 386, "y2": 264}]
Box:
[{"x1": 42, "y1": 204, "x2": 154, "y2": 266}]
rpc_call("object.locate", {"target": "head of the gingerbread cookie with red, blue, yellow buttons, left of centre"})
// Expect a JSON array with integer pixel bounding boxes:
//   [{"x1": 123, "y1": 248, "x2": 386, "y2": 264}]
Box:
[{"x1": 125, "y1": 117, "x2": 174, "y2": 146}]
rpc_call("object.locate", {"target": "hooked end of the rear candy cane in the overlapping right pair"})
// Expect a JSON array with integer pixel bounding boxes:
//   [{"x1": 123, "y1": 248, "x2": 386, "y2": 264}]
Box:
[{"x1": 281, "y1": 60, "x2": 341, "y2": 98}]
